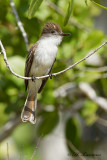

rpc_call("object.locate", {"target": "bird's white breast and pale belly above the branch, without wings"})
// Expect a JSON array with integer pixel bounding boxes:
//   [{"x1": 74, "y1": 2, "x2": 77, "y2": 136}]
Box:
[{"x1": 31, "y1": 36, "x2": 62, "y2": 76}]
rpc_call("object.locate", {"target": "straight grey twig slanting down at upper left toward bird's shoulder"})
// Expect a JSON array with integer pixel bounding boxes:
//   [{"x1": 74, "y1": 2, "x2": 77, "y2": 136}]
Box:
[{"x1": 9, "y1": 0, "x2": 29, "y2": 51}]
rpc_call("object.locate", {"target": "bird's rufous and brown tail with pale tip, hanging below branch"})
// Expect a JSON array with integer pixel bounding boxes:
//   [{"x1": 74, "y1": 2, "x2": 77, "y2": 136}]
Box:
[{"x1": 21, "y1": 93, "x2": 37, "y2": 124}]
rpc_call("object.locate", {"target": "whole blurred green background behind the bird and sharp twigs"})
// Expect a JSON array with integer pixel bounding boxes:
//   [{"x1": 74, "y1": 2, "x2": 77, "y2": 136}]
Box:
[{"x1": 0, "y1": 0, "x2": 107, "y2": 160}]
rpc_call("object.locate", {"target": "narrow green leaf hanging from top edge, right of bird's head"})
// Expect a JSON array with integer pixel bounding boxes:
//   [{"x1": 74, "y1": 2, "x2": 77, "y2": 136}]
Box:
[{"x1": 64, "y1": 0, "x2": 74, "y2": 26}]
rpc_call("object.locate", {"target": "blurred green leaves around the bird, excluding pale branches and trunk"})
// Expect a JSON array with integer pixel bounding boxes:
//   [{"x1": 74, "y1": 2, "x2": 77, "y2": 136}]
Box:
[{"x1": 0, "y1": 0, "x2": 107, "y2": 157}]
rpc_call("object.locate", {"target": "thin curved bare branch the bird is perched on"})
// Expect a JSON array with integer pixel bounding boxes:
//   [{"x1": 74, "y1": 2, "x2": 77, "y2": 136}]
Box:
[{"x1": 0, "y1": 41, "x2": 107, "y2": 80}]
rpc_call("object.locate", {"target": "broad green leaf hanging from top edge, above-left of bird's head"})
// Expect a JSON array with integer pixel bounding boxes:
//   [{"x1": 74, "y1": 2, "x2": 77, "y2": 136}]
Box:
[{"x1": 28, "y1": 0, "x2": 43, "y2": 18}]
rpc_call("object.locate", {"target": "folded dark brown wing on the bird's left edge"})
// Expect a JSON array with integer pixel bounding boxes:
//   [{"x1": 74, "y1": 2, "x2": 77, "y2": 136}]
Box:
[{"x1": 25, "y1": 43, "x2": 37, "y2": 90}]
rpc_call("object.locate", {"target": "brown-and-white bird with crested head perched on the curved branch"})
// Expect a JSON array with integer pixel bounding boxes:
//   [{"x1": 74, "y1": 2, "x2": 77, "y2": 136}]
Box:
[{"x1": 21, "y1": 22, "x2": 70, "y2": 124}]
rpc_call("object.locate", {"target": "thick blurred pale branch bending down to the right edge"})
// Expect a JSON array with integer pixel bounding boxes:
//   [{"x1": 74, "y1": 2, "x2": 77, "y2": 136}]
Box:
[{"x1": 54, "y1": 82, "x2": 107, "y2": 113}]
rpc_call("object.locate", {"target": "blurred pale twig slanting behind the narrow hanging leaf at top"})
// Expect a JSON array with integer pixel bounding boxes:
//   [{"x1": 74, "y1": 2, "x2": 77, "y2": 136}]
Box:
[{"x1": 46, "y1": 1, "x2": 90, "y2": 32}]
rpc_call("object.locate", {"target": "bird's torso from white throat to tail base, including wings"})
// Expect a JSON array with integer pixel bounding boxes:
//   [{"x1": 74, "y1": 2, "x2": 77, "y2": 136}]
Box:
[{"x1": 25, "y1": 36, "x2": 62, "y2": 94}]
